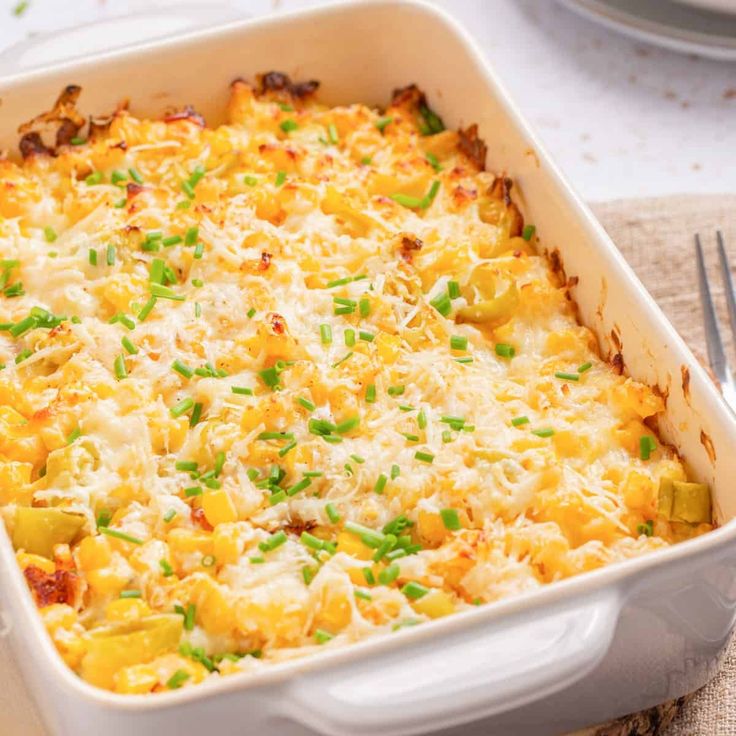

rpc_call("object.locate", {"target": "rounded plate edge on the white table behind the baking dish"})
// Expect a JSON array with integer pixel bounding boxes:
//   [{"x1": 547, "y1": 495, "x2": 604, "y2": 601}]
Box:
[{"x1": 560, "y1": 0, "x2": 736, "y2": 61}]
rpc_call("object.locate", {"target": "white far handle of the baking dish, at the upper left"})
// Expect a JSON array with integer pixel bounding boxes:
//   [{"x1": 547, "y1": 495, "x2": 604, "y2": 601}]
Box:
[{"x1": 0, "y1": 3, "x2": 240, "y2": 77}]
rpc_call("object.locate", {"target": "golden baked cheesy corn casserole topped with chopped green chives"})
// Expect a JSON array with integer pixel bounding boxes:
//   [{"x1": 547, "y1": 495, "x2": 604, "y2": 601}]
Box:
[{"x1": 0, "y1": 77, "x2": 710, "y2": 692}]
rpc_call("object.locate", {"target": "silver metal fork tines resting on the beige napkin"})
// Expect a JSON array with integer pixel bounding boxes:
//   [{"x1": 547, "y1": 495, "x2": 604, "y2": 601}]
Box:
[{"x1": 695, "y1": 230, "x2": 736, "y2": 412}]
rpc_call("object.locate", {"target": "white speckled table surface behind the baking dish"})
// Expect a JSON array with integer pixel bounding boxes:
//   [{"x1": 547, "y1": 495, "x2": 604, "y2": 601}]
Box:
[{"x1": 0, "y1": 0, "x2": 736, "y2": 736}]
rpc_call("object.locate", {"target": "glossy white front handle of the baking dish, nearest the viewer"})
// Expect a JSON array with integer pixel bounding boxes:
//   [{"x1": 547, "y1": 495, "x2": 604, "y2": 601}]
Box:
[{"x1": 281, "y1": 590, "x2": 620, "y2": 736}]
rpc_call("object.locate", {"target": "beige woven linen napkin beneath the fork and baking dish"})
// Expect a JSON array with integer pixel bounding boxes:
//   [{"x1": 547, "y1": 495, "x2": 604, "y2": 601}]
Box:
[{"x1": 0, "y1": 195, "x2": 736, "y2": 736}]
